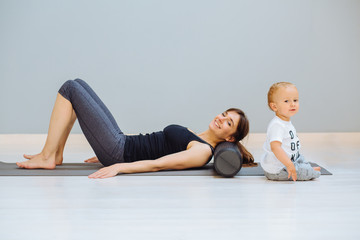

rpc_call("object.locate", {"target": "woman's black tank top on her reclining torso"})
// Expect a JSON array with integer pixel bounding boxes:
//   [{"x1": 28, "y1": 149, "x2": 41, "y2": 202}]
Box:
[{"x1": 124, "y1": 125, "x2": 214, "y2": 162}]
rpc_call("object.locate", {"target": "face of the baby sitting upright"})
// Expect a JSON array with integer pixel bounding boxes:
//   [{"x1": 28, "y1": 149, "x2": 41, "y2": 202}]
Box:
[{"x1": 270, "y1": 86, "x2": 299, "y2": 121}]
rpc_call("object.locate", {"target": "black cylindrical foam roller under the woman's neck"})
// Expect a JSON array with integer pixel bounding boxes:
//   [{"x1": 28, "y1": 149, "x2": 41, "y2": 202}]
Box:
[{"x1": 214, "y1": 142, "x2": 243, "y2": 177}]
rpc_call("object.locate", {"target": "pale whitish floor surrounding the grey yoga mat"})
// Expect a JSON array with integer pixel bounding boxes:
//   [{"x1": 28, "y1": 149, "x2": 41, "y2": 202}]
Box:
[{"x1": 0, "y1": 133, "x2": 360, "y2": 240}]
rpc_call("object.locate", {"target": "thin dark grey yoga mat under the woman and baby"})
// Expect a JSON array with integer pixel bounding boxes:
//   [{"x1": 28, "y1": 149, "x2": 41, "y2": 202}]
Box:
[{"x1": 0, "y1": 161, "x2": 332, "y2": 176}]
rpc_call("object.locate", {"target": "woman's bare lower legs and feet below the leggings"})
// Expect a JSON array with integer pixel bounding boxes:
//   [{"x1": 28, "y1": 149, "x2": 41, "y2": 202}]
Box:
[{"x1": 16, "y1": 94, "x2": 76, "y2": 169}]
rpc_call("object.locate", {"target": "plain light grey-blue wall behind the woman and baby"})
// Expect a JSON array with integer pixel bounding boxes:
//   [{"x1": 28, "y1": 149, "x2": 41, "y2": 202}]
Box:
[{"x1": 0, "y1": 0, "x2": 360, "y2": 133}]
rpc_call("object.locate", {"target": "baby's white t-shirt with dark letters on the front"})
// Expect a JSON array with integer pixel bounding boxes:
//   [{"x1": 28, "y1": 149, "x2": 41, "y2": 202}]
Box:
[{"x1": 261, "y1": 116, "x2": 301, "y2": 174}]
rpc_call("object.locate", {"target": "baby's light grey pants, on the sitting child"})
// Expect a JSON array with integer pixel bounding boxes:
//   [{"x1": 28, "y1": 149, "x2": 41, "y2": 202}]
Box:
[{"x1": 264, "y1": 155, "x2": 321, "y2": 181}]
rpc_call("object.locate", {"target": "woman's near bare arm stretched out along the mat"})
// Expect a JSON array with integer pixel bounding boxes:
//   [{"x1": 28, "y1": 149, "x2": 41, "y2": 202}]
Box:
[{"x1": 89, "y1": 143, "x2": 211, "y2": 178}]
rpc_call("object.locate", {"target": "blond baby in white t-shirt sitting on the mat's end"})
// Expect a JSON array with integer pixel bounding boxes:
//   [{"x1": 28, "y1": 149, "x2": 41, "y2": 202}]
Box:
[{"x1": 261, "y1": 82, "x2": 320, "y2": 181}]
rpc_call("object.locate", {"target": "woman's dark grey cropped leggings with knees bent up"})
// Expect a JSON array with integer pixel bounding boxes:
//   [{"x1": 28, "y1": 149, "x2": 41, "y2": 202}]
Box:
[{"x1": 59, "y1": 79, "x2": 126, "y2": 166}]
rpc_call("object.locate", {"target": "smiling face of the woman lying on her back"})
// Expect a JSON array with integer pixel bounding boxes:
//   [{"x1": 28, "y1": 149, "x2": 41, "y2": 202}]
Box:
[{"x1": 209, "y1": 111, "x2": 240, "y2": 142}]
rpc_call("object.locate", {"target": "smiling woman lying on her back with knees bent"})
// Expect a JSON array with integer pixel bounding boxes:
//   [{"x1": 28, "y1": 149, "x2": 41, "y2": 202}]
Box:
[{"x1": 16, "y1": 79, "x2": 254, "y2": 178}]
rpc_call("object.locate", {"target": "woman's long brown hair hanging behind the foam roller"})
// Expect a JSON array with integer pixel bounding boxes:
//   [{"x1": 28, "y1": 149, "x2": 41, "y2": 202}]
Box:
[{"x1": 226, "y1": 108, "x2": 257, "y2": 166}]
